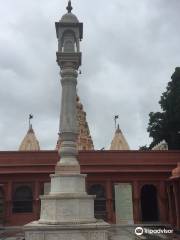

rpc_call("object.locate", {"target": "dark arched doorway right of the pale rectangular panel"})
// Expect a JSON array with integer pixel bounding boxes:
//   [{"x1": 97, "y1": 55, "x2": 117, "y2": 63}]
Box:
[{"x1": 141, "y1": 184, "x2": 159, "y2": 222}]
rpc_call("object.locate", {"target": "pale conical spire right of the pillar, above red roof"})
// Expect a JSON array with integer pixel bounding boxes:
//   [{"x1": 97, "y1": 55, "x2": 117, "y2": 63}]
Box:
[{"x1": 110, "y1": 124, "x2": 130, "y2": 150}]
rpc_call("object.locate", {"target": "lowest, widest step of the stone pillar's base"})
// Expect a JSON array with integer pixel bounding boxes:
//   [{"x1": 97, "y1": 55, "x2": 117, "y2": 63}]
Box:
[{"x1": 24, "y1": 221, "x2": 109, "y2": 240}]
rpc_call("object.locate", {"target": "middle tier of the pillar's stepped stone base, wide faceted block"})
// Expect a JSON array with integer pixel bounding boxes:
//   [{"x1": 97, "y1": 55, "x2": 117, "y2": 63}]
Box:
[{"x1": 40, "y1": 194, "x2": 95, "y2": 223}]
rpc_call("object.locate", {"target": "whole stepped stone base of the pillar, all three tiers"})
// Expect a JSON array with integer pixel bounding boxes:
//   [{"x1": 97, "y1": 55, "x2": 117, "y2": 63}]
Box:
[{"x1": 24, "y1": 173, "x2": 110, "y2": 240}]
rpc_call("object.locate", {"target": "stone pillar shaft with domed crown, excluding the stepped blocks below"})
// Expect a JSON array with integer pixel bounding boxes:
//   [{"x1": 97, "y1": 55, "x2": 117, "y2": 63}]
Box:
[{"x1": 55, "y1": 2, "x2": 83, "y2": 174}]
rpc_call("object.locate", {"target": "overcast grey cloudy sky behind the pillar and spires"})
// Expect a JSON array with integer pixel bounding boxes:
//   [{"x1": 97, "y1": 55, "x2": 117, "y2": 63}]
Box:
[{"x1": 0, "y1": 0, "x2": 180, "y2": 150}]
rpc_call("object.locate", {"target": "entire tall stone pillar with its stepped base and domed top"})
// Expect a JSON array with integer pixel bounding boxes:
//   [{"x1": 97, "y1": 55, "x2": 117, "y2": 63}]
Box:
[{"x1": 25, "y1": 1, "x2": 109, "y2": 240}]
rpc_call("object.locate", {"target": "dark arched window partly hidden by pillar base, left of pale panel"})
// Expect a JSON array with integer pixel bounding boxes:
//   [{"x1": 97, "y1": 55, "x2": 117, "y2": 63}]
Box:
[{"x1": 88, "y1": 184, "x2": 106, "y2": 220}]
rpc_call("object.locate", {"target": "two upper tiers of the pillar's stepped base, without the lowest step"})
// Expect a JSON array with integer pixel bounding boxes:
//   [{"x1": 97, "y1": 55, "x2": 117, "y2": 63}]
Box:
[{"x1": 38, "y1": 174, "x2": 96, "y2": 225}]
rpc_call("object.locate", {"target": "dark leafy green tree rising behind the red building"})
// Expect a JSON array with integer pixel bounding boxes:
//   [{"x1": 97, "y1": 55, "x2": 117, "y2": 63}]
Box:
[{"x1": 147, "y1": 67, "x2": 180, "y2": 149}]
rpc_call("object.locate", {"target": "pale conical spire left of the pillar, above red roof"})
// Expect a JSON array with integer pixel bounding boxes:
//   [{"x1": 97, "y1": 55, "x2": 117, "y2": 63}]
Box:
[{"x1": 19, "y1": 125, "x2": 40, "y2": 151}]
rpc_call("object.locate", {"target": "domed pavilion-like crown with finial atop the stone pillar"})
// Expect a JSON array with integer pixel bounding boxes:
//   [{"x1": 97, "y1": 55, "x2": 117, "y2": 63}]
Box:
[{"x1": 55, "y1": 1, "x2": 83, "y2": 69}]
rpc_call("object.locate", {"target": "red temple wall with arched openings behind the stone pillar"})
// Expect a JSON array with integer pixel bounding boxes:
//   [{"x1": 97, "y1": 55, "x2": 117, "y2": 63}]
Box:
[{"x1": 0, "y1": 151, "x2": 180, "y2": 228}]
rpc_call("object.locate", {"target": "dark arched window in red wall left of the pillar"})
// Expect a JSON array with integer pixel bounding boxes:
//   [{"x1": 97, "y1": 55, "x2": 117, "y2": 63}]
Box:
[{"x1": 13, "y1": 186, "x2": 33, "y2": 213}]
